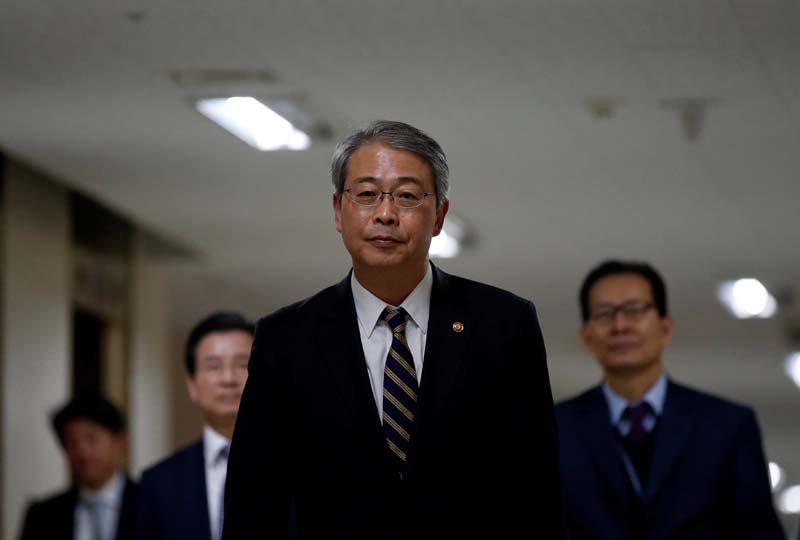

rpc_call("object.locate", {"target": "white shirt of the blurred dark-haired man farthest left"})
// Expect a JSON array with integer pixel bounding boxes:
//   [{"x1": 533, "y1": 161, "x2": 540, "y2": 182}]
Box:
[{"x1": 73, "y1": 472, "x2": 125, "y2": 540}]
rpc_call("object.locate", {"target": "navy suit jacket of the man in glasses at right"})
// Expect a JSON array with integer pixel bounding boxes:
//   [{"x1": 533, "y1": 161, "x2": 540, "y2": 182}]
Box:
[{"x1": 556, "y1": 382, "x2": 784, "y2": 540}]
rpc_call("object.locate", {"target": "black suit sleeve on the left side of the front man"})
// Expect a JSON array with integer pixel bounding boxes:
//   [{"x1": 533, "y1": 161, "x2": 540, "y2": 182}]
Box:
[{"x1": 222, "y1": 319, "x2": 290, "y2": 540}]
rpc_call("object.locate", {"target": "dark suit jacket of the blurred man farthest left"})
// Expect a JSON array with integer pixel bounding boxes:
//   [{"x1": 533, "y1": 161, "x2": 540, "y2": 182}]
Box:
[{"x1": 20, "y1": 479, "x2": 136, "y2": 540}]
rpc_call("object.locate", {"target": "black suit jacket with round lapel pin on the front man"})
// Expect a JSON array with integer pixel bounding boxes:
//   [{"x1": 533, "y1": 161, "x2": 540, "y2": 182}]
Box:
[{"x1": 223, "y1": 267, "x2": 563, "y2": 540}]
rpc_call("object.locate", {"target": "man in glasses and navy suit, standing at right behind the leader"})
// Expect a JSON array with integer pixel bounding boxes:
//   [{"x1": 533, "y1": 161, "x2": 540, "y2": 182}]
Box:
[{"x1": 556, "y1": 261, "x2": 784, "y2": 540}]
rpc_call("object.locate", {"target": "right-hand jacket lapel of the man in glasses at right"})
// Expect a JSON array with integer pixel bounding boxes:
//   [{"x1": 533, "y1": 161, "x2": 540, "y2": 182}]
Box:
[{"x1": 644, "y1": 382, "x2": 692, "y2": 501}]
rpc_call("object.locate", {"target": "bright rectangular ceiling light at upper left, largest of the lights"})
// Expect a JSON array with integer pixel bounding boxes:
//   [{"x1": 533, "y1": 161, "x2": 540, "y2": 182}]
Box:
[{"x1": 197, "y1": 97, "x2": 311, "y2": 150}]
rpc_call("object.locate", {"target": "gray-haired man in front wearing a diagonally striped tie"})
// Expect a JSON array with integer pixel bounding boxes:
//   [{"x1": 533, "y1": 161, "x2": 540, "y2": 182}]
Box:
[{"x1": 223, "y1": 121, "x2": 563, "y2": 540}]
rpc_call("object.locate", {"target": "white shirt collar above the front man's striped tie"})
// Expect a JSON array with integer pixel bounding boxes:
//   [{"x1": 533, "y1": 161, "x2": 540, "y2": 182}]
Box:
[{"x1": 350, "y1": 264, "x2": 433, "y2": 338}]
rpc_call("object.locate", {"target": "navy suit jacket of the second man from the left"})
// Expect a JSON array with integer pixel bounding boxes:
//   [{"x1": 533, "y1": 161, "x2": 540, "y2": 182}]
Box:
[{"x1": 136, "y1": 440, "x2": 211, "y2": 540}]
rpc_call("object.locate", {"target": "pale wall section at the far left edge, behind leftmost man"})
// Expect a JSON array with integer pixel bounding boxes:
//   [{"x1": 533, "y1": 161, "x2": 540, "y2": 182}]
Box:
[{"x1": 0, "y1": 161, "x2": 71, "y2": 540}]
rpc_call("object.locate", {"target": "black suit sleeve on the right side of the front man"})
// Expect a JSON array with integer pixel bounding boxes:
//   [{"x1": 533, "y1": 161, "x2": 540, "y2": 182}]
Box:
[{"x1": 506, "y1": 302, "x2": 567, "y2": 540}]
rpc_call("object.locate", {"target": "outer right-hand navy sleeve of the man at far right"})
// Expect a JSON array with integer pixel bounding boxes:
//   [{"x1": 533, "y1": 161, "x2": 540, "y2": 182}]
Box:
[{"x1": 735, "y1": 409, "x2": 785, "y2": 540}]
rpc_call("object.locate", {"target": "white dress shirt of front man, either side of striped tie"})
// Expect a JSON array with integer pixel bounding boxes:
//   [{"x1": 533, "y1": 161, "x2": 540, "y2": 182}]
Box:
[{"x1": 350, "y1": 264, "x2": 433, "y2": 422}]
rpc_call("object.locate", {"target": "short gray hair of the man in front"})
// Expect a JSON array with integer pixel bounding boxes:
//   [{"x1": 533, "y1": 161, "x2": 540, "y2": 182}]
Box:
[{"x1": 331, "y1": 120, "x2": 450, "y2": 204}]
